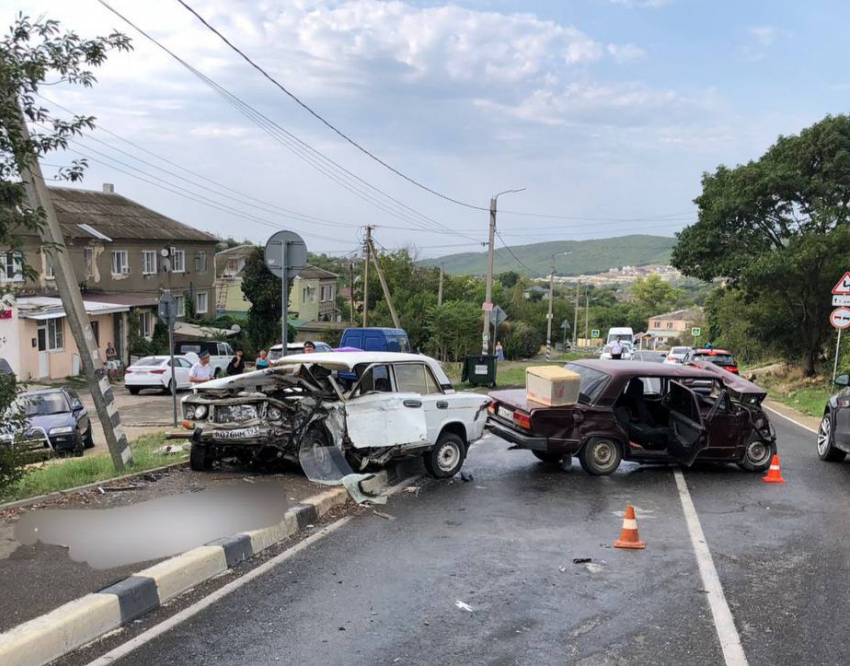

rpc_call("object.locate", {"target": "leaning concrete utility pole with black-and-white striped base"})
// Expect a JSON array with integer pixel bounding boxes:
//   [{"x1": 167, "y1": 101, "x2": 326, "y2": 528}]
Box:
[{"x1": 13, "y1": 104, "x2": 133, "y2": 472}]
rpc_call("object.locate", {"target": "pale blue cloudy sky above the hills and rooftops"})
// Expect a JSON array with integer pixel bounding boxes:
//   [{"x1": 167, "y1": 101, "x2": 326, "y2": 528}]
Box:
[{"x1": 0, "y1": 0, "x2": 850, "y2": 257}]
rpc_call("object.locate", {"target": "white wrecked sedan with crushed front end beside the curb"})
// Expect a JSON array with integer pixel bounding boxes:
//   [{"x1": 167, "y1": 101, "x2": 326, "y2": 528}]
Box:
[{"x1": 183, "y1": 352, "x2": 489, "y2": 478}]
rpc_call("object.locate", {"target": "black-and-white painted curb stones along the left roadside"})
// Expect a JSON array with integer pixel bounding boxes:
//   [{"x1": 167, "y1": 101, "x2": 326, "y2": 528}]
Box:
[{"x1": 0, "y1": 462, "x2": 419, "y2": 666}]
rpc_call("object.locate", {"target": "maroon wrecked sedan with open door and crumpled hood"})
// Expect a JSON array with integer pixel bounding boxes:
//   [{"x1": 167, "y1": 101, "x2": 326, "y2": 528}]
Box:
[{"x1": 487, "y1": 360, "x2": 776, "y2": 475}]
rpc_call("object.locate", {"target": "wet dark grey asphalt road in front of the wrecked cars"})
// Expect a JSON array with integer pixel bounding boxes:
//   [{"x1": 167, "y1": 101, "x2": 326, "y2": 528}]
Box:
[{"x1": 61, "y1": 416, "x2": 850, "y2": 666}]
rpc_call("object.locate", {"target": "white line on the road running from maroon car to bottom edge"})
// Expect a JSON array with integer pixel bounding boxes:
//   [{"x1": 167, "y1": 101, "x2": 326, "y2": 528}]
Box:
[{"x1": 673, "y1": 469, "x2": 747, "y2": 666}]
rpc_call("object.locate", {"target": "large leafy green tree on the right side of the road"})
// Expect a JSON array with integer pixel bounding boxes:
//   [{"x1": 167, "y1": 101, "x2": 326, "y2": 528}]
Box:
[{"x1": 672, "y1": 115, "x2": 850, "y2": 376}]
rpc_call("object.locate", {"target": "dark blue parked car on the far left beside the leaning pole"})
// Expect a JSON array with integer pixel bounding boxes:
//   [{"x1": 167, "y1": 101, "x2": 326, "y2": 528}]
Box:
[{"x1": 0, "y1": 388, "x2": 94, "y2": 456}]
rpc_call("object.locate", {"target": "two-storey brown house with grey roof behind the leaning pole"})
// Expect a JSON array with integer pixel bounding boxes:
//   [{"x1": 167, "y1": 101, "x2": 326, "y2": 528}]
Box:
[{"x1": 0, "y1": 184, "x2": 217, "y2": 379}]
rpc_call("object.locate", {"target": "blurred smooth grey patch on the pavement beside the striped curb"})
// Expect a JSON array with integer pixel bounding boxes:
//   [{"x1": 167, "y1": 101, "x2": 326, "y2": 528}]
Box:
[{"x1": 15, "y1": 483, "x2": 293, "y2": 569}]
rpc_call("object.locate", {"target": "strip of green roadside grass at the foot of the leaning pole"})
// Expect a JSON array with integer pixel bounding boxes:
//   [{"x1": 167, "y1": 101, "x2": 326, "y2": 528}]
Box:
[{"x1": 0, "y1": 433, "x2": 180, "y2": 502}]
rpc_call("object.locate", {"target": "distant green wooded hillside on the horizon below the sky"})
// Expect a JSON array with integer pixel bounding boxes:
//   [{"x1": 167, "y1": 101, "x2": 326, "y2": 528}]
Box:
[{"x1": 422, "y1": 235, "x2": 676, "y2": 277}]
